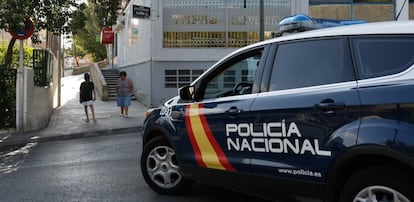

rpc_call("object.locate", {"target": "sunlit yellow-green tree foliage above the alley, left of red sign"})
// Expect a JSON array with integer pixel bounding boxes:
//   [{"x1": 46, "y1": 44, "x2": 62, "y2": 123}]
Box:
[{"x1": 69, "y1": 0, "x2": 121, "y2": 61}]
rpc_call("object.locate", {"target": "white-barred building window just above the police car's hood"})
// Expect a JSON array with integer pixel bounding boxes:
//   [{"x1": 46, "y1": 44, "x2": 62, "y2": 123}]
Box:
[{"x1": 164, "y1": 69, "x2": 204, "y2": 88}]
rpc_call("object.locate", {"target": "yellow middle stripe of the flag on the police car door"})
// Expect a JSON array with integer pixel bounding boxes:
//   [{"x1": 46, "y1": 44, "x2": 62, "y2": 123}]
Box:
[{"x1": 189, "y1": 104, "x2": 225, "y2": 170}]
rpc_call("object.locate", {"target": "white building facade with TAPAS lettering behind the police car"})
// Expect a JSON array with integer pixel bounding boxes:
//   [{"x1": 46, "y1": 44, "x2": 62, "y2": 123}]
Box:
[{"x1": 114, "y1": 0, "x2": 309, "y2": 106}]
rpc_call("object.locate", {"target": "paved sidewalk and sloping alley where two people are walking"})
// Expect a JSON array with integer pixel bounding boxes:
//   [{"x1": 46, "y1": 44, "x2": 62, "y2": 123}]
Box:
[{"x1": 0, "y1": 74, "x2": 147, "y2": 146}]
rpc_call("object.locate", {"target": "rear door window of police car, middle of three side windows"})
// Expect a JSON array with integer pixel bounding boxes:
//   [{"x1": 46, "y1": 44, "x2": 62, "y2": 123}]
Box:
[{"x1": 269, "y1": 38, "x2": 355, "y2": 91}]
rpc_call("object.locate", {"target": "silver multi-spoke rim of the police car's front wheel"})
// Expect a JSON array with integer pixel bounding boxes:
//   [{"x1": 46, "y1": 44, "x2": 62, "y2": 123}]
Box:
[{"x1": 147, "y1": 146, "x2": 182, "y2": 189}]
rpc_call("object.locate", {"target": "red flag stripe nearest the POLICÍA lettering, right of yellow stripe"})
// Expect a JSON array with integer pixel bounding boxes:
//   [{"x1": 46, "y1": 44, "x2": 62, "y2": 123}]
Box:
[{"x1": 199, "y1": 104, "x2": 236, "y2": 171}]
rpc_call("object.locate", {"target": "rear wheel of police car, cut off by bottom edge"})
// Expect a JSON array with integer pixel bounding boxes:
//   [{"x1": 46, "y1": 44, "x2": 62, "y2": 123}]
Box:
[{"x1": 339, "y1": 166, "x2": 414, "y2": 202}]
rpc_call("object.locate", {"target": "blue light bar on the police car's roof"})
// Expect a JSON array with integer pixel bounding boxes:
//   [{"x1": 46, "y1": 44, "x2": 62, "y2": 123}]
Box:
[{"x1": 277, "y1": 14, "x2": 367, "y2": 36}]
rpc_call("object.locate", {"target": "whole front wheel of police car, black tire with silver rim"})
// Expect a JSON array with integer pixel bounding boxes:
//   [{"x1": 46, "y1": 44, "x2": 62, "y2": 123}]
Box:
[{"x1": 141, "y1": 137, "x2": 192, "y2": 195}]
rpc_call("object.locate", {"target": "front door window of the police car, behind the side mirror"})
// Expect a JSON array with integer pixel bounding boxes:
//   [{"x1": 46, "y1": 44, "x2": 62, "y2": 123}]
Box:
[{"x1": 203, "y1": 50, "x2": 262, "y2": 99}]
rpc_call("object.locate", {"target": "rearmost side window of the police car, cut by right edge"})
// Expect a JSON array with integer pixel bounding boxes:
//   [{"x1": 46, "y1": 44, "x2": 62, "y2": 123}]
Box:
[{"x1": 352, "y1": 36, "x2": 414, "y2": 79}]
